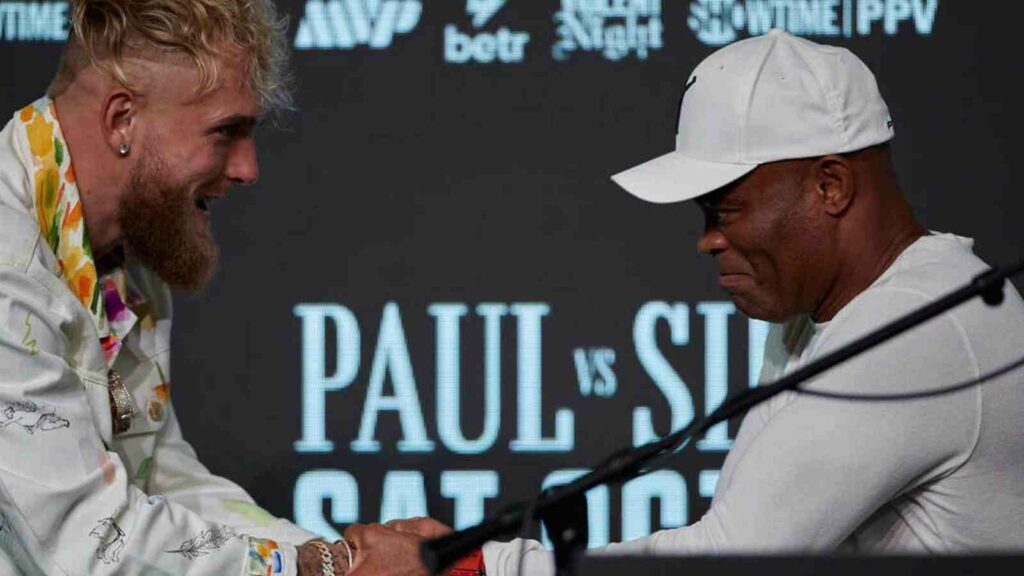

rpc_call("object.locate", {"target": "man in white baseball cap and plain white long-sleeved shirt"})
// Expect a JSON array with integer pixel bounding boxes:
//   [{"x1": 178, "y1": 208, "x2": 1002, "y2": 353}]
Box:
[{"x1": 335, "y1": 31, "x2": 1024, "y2": 576}]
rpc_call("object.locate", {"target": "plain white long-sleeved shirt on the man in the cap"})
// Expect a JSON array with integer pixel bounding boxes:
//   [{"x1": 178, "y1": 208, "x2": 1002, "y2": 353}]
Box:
[{"x1": 483, "y1": 230, "x2": 1024, "y2": 576}]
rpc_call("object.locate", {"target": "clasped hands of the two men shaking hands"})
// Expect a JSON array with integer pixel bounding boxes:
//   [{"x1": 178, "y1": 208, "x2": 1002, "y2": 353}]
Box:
[{"x1": 297, "y1": 518, "x2": 452, "y2": 576}]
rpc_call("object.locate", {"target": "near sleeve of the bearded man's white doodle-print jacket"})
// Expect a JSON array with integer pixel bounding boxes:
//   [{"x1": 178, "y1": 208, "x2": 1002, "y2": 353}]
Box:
[{"x1": 0, "y1": 261, "x2": 296, "y2": 576}]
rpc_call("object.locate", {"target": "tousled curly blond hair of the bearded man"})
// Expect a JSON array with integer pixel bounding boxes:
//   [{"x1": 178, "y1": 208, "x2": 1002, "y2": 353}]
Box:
[{"x1": 49, "y1": 0, "x2": 292, "y2": 114}]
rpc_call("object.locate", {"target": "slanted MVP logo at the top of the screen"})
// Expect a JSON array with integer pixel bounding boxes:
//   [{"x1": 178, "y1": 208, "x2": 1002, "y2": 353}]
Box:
[{"x1": 295, "y1": 0, "x2": 423, "y2": 50}]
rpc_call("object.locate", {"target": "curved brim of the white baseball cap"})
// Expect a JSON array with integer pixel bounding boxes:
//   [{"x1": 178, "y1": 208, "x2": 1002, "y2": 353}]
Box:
[{"x1": 611, "y1": 152, "x2": 758, "y2": 204}]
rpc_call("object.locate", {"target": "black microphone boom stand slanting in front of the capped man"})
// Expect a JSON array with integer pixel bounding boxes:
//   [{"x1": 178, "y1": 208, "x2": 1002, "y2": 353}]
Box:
[{"x1": 420, "y1": 260, "x2": 1024, "y2": 576}]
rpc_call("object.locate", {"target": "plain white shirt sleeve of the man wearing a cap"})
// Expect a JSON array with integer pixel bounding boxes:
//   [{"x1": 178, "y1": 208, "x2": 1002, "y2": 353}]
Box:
[{"x1": 484, "y1": 289, "x2": 981, "y2": 576}]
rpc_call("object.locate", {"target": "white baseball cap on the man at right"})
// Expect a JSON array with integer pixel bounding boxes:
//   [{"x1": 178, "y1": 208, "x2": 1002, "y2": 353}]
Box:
[{"x1": 611, "y1": 29, "x2": 893, "y2": 203}]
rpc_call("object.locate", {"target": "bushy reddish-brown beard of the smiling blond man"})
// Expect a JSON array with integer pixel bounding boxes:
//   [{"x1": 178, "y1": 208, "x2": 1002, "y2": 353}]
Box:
[{"x1": 120, "y1": 155, "x2": 219, "y2": 292}]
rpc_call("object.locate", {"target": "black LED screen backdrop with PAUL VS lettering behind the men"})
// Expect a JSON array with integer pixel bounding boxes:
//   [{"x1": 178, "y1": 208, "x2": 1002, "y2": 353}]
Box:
[{"x1": 0, "y1": 0, "x2": 1024, "y2": 544}]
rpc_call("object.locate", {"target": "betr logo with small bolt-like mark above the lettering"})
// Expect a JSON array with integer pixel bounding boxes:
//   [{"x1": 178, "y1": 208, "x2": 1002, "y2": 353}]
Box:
[{"x1": 444, "y1": 0, "x2": 529, "y2": 64}]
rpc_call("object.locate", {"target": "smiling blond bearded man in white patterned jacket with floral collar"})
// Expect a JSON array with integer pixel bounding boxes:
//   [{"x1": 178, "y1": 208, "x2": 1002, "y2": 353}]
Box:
[{"x1": 0, "y1": 0, "x2": 350, "y2": 576}]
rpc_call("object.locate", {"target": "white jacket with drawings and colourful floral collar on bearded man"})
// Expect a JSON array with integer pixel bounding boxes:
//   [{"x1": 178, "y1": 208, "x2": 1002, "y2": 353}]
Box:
[{"x1": 0, "y1": 98, "x2": 316, "y2": 576}]
